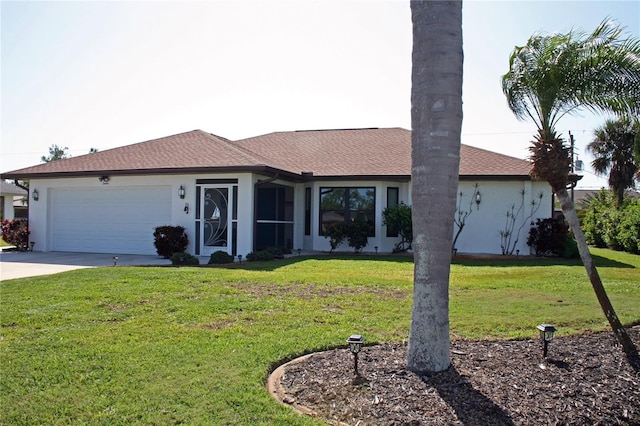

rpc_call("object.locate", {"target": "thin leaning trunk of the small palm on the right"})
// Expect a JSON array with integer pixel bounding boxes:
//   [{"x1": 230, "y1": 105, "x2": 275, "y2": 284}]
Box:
[{"x1": 556, "y1": 188, "x2": 639, "y2": 370}]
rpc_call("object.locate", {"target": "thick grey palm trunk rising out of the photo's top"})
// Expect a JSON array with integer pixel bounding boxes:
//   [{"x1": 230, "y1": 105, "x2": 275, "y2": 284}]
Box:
[{"x1": 407, "y1": 0, "x2": 462, "y2": 372}]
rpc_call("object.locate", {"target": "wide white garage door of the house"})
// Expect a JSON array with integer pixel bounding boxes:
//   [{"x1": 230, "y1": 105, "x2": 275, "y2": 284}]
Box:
[{"x1": 50, "y1": 187, "x2": 171, "y2": 254}]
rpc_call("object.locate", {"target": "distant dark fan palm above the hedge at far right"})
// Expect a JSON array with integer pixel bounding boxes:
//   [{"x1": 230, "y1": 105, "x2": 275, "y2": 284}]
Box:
[{"x1": 587, "y1": 117, "x2": 640, "y2": 207}]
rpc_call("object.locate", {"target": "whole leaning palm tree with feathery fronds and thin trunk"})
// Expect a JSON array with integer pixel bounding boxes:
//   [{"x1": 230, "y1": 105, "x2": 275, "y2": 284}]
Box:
[{"x1": 502, "y1": 21, "x2": 640, "y2": 366}]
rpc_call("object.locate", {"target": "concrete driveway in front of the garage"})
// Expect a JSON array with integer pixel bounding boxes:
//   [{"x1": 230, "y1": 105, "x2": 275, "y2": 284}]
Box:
[{"x1": 0, "y1": 251, "x2": 171, "y2": 280}]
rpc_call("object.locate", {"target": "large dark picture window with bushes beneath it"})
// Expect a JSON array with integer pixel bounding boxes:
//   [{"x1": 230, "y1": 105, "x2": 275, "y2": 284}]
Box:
[{"x1": 319, "y1": 187, "x2": 376, "y2": 237}]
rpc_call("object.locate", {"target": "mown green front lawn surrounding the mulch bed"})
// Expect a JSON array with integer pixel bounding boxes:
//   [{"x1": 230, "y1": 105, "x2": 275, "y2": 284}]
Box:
[{"x1": 0, "y1": 249, "x2": 640, "y2": 425}]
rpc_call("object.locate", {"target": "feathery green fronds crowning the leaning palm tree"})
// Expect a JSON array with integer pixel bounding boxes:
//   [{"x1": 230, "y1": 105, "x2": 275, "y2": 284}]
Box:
[{"x1": 502, "y1": 20, "x2": 640, "y2": 132}]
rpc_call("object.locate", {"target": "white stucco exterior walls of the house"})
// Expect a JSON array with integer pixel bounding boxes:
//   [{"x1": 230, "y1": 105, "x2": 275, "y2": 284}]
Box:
[{"x1": 29, "y1": 173, "x2": 551, "y2": 256}]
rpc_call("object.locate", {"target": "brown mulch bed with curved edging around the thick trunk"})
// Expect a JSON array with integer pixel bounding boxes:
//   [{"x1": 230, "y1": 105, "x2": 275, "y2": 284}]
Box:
[{"x1": 279, "y1": 326, "x2": 640, "y2": 426}]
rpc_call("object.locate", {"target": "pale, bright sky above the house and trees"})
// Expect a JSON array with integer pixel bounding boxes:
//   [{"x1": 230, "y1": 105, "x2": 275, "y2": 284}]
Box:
[{"x1": 0, "y1": 0, "x2": 640, "y2": 187}]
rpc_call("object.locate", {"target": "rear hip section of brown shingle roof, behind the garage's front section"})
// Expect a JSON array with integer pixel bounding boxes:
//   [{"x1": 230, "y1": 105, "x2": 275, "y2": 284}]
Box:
[{"x1": 235, "y1": 128, "x2": 531, "y2": 176}]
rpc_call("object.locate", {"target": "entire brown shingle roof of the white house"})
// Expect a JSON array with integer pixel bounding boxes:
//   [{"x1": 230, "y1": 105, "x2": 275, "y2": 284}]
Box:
[{"x1": 4, "y1": 128, "x2": 531, "y2": 179}]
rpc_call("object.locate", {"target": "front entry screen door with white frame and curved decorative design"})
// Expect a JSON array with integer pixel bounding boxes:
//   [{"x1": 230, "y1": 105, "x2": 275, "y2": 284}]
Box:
[{"x1": 200, "y1": 186, "x2": 233, "y2": 256}]
